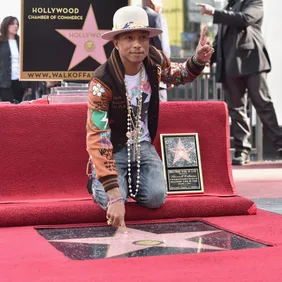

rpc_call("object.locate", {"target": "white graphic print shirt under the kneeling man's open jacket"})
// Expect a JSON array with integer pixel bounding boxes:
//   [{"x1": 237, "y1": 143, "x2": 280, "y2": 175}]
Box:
[{"x1": 125, "y1": 70, "x2": 152, "y2": 142}]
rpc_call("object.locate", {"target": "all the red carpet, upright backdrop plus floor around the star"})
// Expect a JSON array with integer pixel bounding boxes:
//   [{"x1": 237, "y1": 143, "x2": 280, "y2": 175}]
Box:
[{"x1": 0, "y1": 102, "x2": 282, "y2": 282}]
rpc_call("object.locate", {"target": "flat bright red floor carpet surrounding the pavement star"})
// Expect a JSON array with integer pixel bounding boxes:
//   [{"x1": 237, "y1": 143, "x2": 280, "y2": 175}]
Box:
[{"x1": 0, "y1": 208, "x2": 282, "y2": 282}]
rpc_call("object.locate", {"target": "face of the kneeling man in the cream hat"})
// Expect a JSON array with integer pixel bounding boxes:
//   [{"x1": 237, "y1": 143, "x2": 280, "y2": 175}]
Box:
[{"x1": 114, "y1": 31, "x2": 149, "y2": 64}]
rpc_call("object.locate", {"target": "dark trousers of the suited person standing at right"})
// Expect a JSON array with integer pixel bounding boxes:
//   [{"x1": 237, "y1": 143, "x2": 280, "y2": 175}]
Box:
[{"x1": 222, "y1": 72, "x2": 282, "y2": 152}]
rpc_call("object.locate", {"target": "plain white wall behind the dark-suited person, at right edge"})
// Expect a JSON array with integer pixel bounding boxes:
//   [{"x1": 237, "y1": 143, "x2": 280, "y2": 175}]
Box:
[{"x1": 263, "y1": 0, "x2": 282, "y2": 125}]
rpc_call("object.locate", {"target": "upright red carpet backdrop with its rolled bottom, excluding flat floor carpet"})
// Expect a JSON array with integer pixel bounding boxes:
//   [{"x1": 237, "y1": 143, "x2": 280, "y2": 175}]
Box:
[{"x1": 0, "y1": 102, "x2": 256, "y2": 226}]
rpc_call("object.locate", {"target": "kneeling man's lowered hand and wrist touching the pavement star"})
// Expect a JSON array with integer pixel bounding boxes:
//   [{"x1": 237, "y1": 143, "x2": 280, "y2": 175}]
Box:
[{"x1": 107, "y1": 188, "x2": 125, "y2": 228}]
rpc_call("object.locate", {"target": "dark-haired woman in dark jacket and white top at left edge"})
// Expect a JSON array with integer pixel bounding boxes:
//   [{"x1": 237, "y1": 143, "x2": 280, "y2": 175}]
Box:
[{"x1": 0, "y1": 16, "x2": 31, "y2": 103}]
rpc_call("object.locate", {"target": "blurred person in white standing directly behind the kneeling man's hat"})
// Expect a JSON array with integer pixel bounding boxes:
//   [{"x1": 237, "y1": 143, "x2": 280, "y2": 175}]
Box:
[{"x1": 142, "y1": 0, "x2": 171, "y2": 102}]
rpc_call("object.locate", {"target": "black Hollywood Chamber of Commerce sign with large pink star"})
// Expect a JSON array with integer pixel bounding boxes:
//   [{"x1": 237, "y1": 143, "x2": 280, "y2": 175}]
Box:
[{"x1": 20, "y1": 0, "x2": 128, "y2": 81}]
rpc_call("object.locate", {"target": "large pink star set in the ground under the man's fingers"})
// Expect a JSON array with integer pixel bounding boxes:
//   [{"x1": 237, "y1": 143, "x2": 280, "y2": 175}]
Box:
[{"x1": 50, "y1": 228, "x2": 226, "y2": 258}]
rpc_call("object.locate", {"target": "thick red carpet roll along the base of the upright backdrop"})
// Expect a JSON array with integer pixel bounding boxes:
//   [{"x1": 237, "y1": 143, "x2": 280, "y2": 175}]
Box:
[{"x1": 0, "y1": 196, "x2": 256, "y2": 226}]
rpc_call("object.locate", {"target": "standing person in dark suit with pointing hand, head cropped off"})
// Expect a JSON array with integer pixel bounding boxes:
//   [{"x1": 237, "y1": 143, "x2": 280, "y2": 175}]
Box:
[{"x1": 197, "y1": 0, "x2": 282, "y2": 165}]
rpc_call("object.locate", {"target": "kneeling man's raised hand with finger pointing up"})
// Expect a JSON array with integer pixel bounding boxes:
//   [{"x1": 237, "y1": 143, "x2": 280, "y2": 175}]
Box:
[{"x1": 195, "y1": 26, "x2": 214, "y2": 64}]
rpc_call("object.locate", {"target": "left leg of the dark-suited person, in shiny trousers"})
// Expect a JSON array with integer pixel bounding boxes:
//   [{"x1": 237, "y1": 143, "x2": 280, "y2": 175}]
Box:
[{"x1": 222, "y1": 77, "x2": 252, "y2": 165}]
